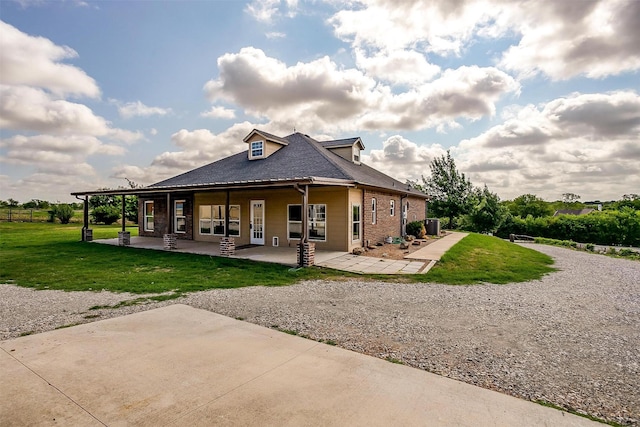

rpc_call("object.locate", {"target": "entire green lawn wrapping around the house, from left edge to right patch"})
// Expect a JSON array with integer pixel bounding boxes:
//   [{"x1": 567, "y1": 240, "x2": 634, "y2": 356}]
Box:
[{"x1": 0, "y1": 222, "x2": 553, "y2": 295}]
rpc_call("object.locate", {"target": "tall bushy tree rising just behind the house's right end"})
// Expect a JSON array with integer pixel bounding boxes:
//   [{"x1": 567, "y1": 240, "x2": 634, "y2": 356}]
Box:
[{"x1": 422, "y1": 151, "x2": 473, "y2": 229}]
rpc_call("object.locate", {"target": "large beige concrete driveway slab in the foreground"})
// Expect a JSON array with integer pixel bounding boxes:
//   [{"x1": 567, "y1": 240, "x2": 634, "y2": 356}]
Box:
[{"x1": 0, "y1": 305, "x2": 600, "y2": 427}]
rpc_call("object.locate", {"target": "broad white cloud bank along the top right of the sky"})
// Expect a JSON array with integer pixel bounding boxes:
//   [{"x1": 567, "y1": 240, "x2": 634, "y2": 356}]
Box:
[{"x1": 329, "y1": 0, "x2": 640, "y2": 80}]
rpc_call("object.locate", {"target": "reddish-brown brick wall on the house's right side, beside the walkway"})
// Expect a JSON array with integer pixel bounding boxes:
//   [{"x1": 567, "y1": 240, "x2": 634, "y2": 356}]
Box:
[{"x1": 362, "y1": 190, "x2": 425, "y2": 245}]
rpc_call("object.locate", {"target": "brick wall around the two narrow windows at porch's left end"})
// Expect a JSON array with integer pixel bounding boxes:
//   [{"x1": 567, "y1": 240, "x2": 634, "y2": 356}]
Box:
[{"x1": 138, "y1": 194, "x2": 193, "y2": 240}]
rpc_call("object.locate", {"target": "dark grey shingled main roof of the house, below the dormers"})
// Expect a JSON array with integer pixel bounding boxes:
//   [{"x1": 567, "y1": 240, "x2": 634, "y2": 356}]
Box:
[{"x1": 149, "y1": 132, "x2": 425, "y2": 196}]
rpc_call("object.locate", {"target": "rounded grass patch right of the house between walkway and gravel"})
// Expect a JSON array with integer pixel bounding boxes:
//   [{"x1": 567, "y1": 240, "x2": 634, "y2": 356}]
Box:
[{"x1": 421, "y1": 233, "x2": 555, "y2": 285}]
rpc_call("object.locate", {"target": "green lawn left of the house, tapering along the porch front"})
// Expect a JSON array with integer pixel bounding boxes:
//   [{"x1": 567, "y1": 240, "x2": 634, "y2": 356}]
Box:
[{"x1": 0, "y1": 222, "x2": 348, "y2": 294}]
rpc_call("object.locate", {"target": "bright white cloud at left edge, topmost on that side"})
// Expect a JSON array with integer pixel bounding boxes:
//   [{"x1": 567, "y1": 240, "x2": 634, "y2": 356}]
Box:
[{"x1": 0, "y1": 21, "x2": 100, "y2": 98}]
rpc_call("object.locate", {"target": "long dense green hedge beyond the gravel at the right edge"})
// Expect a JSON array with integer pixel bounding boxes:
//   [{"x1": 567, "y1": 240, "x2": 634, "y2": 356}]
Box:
[{"x1": 495, "y1": 208, "x2": 640, "y2": 246}]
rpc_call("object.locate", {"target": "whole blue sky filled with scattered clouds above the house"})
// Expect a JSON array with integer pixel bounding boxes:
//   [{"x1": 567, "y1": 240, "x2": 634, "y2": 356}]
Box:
[{"x1": 0, "y1": 0, "x2": 640, "y2": 202}]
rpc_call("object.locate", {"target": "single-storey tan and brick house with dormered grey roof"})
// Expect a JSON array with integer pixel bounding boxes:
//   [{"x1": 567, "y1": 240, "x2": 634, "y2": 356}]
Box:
[{"x1": 73, "y1": 129, "x2": 428, "y2": 266}]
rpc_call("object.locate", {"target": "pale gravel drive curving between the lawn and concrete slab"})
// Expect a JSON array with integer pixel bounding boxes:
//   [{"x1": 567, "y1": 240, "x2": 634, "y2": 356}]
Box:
[{"x1": 0, "y1": 245, "x2": 640, "y2": 425}]
